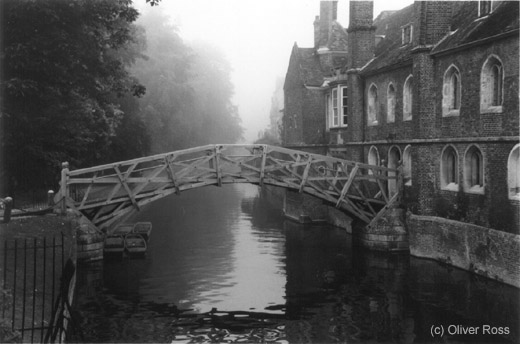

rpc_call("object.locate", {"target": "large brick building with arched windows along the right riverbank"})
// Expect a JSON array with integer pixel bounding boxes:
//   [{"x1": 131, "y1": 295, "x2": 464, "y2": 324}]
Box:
[{"x1": 282, "y1": 1, "x2": 520, "y2": 233}]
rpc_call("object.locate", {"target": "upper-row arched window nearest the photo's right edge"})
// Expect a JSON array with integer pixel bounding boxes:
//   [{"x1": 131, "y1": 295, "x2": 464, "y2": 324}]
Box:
[{"x1": 480, "y1": 55, "x2": 504, "y2": 113}]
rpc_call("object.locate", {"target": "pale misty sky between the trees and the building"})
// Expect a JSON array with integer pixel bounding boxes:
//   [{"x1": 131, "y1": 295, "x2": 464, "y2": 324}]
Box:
[{"x1": 134, "y1": 0, "x2": 413, "y2": 143}]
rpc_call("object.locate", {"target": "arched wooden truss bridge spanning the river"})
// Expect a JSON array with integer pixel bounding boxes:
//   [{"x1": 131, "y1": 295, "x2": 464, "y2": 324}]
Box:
[{"x1": 56, "y1": 144, "x2": 402, "y2": 228}]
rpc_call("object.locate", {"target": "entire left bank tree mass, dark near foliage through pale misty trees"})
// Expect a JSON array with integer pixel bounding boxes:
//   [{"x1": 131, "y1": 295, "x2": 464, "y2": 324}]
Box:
[{"x1": 0, "y1": 0, "x2": 242, "y2": 194}]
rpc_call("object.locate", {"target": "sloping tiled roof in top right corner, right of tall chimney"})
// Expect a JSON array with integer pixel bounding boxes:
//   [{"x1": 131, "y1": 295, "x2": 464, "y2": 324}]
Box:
[{"x1": 432, "y1": 1, "x2": 520, "y2": 54}]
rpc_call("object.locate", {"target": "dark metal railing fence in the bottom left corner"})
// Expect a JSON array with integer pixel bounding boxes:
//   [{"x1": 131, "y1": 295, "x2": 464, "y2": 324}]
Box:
[{"x1": 1, "y1": 233, "x2": 75, "y2": 343}]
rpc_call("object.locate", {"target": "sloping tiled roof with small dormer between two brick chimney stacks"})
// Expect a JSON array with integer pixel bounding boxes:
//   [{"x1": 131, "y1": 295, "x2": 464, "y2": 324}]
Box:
[{"x1": 362, "y1": 4, "x2": 413, "y2": 74}]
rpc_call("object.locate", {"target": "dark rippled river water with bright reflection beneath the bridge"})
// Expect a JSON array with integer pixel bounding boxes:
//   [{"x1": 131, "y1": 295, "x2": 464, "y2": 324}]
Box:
[{"x1": 71, "y1": 184, "x2": 520, "y2": 343}]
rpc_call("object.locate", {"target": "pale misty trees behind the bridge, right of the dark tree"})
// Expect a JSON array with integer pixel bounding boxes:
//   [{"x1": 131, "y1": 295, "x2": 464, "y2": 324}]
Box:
[{"x1": 133, "y1": 10, "x2": 242, "y2": 153}]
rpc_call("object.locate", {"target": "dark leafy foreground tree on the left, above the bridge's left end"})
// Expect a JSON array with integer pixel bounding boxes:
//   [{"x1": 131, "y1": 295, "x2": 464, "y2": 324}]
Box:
[{"x1": 1, "y1": 0, "x2": 144, "y2": 191}]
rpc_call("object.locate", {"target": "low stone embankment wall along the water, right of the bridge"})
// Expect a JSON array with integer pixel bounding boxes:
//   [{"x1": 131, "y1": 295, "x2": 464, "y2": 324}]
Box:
[{"x1": 407, "y1": 215, "x2": 520, "y2": 288}]
